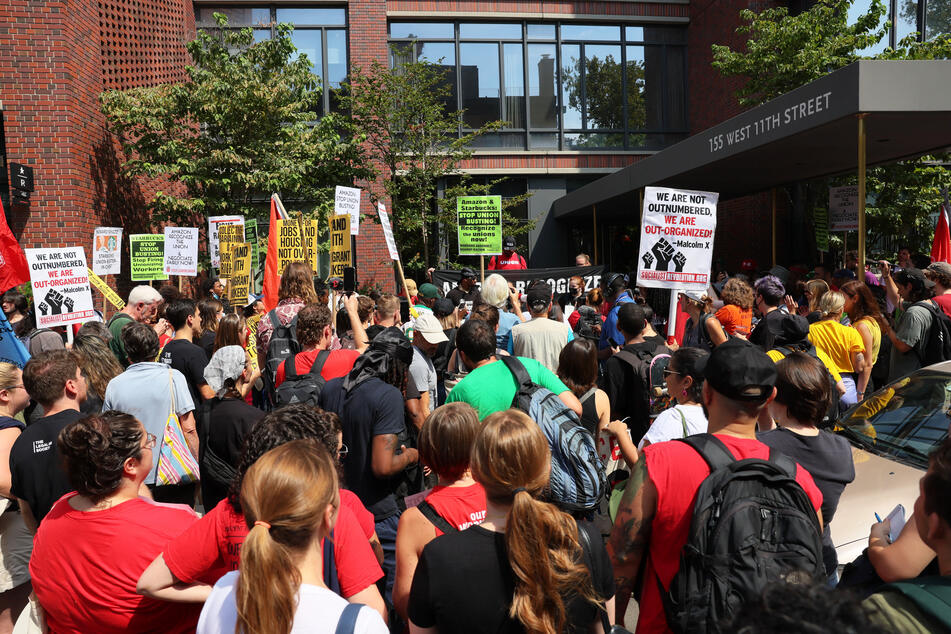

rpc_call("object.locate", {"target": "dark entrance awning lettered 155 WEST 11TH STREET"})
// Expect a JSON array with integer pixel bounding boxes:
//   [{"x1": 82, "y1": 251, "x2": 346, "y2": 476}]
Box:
[{"x1": 552, "y1": 60, "x2": 951, "y2": 220}]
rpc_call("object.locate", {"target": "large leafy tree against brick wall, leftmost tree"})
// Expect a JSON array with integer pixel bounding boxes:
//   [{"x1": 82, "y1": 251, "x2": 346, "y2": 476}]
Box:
[{"x1": 101, "y1": 13, "x2": 369, "y2": 235}]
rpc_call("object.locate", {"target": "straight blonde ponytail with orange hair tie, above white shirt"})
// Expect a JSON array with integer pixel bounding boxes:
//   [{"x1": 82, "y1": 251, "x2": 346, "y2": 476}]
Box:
[{"x1": 235, "y1": 439, "x2": 340, "y2": 634}]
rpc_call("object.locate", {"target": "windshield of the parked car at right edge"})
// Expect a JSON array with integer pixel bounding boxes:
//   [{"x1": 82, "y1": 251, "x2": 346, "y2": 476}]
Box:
[{"x1": 835, "y1": 370, "x2": 951, "y2": 469}]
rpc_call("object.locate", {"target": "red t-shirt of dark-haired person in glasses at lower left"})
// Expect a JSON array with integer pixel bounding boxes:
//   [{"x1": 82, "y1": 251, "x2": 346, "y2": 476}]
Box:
[{"x1": 30, "y1": 493, "x2": 201, "y2": 634}]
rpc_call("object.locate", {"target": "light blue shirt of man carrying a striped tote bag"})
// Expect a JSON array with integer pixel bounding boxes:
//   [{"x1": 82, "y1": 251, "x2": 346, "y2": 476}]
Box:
[{"x1": 102, "y1": 361, "x2": 195, "y2": 484}]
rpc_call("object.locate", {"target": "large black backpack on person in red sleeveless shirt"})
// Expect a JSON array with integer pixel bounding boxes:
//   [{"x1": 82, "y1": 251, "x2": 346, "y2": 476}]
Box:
[{"x1": 657, "y1": 434, "x2": 825, "y2": 634}]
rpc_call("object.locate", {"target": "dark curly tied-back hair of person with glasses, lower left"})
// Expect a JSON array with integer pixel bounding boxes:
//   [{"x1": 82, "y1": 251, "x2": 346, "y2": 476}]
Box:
[{"x1": 56, "y1": 411, "x2": 145, "y2": 504}]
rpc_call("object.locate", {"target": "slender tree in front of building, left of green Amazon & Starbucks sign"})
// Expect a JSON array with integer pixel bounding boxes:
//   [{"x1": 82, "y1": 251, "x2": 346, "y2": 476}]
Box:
[{"x1": 342, "y1": 48, "x2": 531, "y2": 267}]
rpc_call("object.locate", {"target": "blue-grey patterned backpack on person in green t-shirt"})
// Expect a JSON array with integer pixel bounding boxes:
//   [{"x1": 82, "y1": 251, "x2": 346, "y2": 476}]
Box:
[{"x1": 501, "y1": 357, "x2": 607, "y2": 511}]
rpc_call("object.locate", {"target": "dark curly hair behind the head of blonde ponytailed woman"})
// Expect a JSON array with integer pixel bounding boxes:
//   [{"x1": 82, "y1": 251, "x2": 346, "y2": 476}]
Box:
[{"x1": 228, "y1": 404, "x2": 342, "y2": 515}]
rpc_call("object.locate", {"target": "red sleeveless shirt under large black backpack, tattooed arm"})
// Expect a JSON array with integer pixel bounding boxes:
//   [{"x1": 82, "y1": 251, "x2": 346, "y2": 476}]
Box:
[{"x1": 636, "y1": 434, "x2": 822, "y2": 634}]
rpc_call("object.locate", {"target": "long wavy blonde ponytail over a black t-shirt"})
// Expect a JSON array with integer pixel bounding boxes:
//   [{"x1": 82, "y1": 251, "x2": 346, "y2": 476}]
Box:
[{"x1": 470, "y1": 409, "x2": 600, "y2": 634}]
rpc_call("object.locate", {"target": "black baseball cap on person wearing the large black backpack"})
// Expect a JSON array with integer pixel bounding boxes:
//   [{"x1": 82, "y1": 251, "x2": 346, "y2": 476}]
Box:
[{"x1": 697, "y1": 339, "x2": 776, "y2": 401}]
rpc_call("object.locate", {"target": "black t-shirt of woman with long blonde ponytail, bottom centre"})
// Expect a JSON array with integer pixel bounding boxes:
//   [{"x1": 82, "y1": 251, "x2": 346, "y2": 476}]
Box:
[{"x1": 410, "y1": 520, "x2": 614, "y2": 634}]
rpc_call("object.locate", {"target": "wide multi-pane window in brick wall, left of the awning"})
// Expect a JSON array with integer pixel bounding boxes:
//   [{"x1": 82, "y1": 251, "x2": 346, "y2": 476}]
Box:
[{"x1": 390, "y1": 22, "x2": 687, "y2": 150}]
